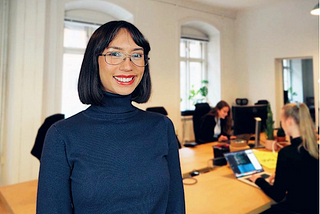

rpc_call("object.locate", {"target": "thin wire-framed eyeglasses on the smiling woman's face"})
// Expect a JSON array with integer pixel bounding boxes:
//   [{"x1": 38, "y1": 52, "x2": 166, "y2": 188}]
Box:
[{"x1": 99, "y1": 51, "x2": 150, "y2": 67}]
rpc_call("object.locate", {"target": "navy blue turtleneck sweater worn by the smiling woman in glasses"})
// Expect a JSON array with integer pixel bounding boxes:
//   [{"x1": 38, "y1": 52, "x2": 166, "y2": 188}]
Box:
[{"x1": 37, "y1": 93, "x2": 185, "y2": 214}]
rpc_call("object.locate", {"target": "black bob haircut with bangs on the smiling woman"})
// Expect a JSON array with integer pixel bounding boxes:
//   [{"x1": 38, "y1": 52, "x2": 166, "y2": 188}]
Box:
[{"x1": 78, "y1": 21, "x2": 151, "y2": 106}]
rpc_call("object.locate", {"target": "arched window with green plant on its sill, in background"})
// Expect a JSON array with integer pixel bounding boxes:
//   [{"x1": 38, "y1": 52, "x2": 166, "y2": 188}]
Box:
[{"x1": 180, "y1": 21, "x2": 221, "y2": 111}]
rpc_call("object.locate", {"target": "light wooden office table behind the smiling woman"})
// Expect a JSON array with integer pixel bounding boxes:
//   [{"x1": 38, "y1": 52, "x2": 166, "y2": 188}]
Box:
[{"x1": 0, "y1": 143, "x2": 272, "y2": 214}]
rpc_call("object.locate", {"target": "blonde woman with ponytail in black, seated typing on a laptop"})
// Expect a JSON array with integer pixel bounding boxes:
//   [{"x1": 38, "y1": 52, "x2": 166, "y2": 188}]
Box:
[{"x1": 250, "y1": 103, "x2": 319, "y2": 214}]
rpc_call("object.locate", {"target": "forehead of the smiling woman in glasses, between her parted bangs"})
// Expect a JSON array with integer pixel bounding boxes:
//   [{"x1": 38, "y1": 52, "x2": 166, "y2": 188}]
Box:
[{"x1": 108, "y1": 28, "x2": 141, "y2": 50}]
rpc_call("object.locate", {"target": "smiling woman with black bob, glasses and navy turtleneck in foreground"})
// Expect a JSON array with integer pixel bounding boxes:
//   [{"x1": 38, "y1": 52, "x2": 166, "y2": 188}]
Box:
[{"x1": 37, "y1": 21, "x2": 185, "y2": 214}]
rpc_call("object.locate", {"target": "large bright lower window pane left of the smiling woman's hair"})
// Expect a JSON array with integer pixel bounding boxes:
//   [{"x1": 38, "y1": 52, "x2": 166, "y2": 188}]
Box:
[{"x1": 61, "y1": 53, "x2": 87, "y2": 117}]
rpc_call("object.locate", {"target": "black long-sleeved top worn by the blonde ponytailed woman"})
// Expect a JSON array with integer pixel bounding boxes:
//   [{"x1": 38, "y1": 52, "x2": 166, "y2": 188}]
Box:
[{"x1": 255, "y1": 137, "x2": 319, "y2": 214}]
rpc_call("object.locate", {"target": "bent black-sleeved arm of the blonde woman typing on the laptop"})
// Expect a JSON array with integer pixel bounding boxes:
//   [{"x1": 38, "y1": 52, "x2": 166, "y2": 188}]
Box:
[{"x1": 255, "y1": 150, "x2": 291, "y2": 202}]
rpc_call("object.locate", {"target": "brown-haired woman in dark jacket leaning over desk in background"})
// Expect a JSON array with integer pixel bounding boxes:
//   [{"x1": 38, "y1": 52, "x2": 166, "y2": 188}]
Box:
[{"x1": 199, "y1": 100, "x2": 235, "y2": 143}]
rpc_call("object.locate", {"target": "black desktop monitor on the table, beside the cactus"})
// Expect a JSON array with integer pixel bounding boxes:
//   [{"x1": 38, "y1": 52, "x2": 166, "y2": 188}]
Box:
[{"x1": 232, "y1": 104, "x2": 268, "y2": 135}]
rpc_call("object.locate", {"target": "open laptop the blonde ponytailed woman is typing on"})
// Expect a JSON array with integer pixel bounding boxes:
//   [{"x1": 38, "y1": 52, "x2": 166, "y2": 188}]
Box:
[{"x1": 223, "y1": 149, "x2": 271, "y2": 188}]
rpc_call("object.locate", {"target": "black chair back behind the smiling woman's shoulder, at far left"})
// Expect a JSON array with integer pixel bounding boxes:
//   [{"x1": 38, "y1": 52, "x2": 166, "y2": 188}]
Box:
[{"x1": 31, "y1": 114, "x2": 64, "y2": 161}]
